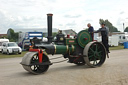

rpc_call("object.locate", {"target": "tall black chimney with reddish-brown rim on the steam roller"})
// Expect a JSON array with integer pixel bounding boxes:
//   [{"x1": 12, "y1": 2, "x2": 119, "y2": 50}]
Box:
[{"x1": 47, "y1": 14, "x2": 53, "y2": 43}]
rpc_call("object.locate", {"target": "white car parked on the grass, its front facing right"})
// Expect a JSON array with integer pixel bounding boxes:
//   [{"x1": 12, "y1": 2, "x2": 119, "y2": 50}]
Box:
[{"x1": 2, "y1": 42, "x2": 22, "y2": 55}]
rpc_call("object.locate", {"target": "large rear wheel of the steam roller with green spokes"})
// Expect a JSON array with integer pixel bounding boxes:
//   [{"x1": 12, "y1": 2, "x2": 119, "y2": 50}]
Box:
[{"x1": 83, "y1": 42, "x2": 106, "y2": 67}]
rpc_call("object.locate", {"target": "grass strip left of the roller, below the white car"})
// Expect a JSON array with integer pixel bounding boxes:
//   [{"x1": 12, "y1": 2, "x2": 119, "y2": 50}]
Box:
[{"x1": 0, "y1": 51, "x2": 28, "y2": 59}]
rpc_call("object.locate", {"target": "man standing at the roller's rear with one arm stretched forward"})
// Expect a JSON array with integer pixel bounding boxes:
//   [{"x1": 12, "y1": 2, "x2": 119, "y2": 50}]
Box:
[{"x1": 94, "y1": 23, "x2": 110, "y2": 53}]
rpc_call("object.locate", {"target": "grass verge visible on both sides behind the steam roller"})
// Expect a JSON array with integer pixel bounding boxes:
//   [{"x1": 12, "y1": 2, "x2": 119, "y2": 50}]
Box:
[{"x1": 0, "y1": 46, "x2": 124, "y2": 59}]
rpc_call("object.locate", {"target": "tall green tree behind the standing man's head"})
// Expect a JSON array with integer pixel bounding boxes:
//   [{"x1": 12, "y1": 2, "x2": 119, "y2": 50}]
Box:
[{"x1": 99, "y1": 19, "x2": 119, "y2": 32}]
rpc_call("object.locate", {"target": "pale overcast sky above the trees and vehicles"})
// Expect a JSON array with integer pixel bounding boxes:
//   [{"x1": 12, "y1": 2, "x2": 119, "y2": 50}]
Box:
[{"x1": 0, "y1": 0, "x2": 128, "y2": 34}]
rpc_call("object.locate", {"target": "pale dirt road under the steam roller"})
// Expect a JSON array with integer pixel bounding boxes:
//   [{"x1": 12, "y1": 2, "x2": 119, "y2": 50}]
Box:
[{"x1": 0, "y1": 50, "x2": 128, "y2": 85}]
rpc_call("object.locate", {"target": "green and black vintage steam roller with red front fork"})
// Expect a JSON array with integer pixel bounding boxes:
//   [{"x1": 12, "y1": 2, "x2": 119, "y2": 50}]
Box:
[{"x1": 21, "y1": 14, "x2": 106, "y2": 74}]
